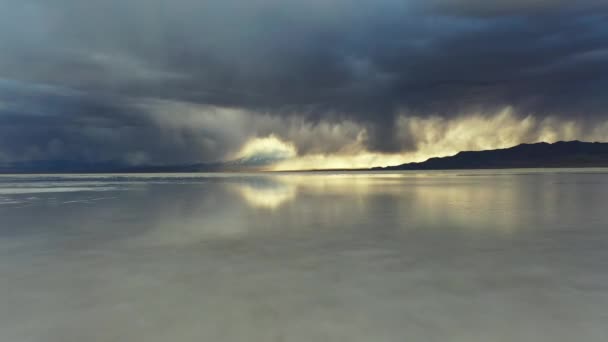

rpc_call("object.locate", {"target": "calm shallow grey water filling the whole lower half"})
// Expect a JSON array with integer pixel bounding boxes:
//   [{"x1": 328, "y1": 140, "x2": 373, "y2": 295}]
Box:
[{"x1": 0, "y1": 169, "x2": 608, "y2": 342}]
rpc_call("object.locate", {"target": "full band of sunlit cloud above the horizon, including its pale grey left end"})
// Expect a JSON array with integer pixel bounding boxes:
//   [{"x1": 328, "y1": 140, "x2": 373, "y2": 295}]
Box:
[{"x1": 144, "y1": 101, "x2": 608, "y2": 171}]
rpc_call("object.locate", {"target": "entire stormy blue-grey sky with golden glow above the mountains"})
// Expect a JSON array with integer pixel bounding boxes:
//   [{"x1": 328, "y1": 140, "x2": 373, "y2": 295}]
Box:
[{"x1": 0, "y1": 0, "x2": 608, "y2": 170}]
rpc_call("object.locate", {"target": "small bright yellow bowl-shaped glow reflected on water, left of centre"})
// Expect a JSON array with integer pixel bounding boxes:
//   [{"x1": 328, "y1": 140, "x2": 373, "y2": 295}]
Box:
[{"x1": 230, "y1": 180, "x2": 297, "y2": 210}]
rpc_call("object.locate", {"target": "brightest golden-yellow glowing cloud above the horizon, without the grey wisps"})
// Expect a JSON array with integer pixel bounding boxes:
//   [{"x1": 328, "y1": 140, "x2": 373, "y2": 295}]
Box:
[{"x1": 238, "y1": 107, "x2": 608, "y2": 171}]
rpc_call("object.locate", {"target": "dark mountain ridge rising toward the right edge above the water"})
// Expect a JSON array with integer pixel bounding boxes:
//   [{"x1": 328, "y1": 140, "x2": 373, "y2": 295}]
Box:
[{"x1": 372, "y1": 141, "x2": 608, "y2": 171}]
